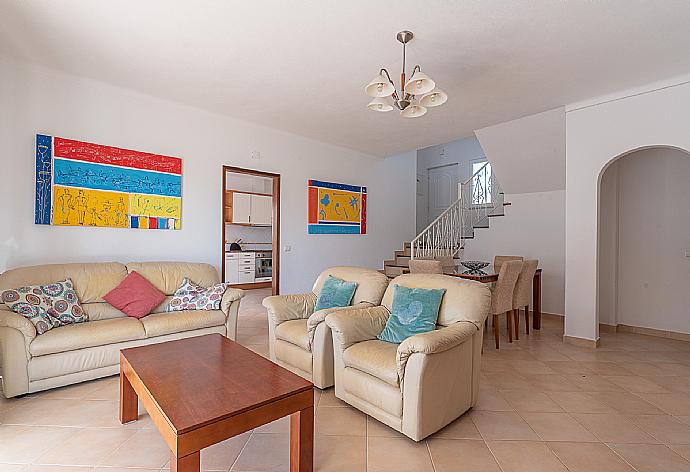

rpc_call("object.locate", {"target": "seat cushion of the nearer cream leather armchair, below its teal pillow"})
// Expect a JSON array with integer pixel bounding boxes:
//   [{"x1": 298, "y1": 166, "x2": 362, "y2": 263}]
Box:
[{"x1": 343, "y1": 340, "x2": 400, "y2": 387}]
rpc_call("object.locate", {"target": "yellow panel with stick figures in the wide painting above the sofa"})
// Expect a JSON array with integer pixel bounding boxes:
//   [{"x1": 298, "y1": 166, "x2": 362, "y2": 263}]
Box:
[{"x1": 53, "y1": 185, "x2": 129, "y2": 228}]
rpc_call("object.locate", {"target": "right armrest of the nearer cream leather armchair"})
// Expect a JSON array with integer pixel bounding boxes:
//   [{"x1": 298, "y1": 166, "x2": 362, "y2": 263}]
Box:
[{"x1": 395, "y1": 321, "x2": 479, "y2": 379}]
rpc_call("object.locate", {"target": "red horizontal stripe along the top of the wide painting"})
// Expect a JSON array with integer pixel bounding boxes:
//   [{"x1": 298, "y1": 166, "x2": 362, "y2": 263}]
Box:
[{"x1": 53, "y1": 136, "x2": 182, "y2": 175}]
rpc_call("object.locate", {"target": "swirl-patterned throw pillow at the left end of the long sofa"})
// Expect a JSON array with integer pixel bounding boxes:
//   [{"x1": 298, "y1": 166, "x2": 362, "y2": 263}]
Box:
[{"x1": 0, "y1": 279, "x2": 89, "y2": 334}]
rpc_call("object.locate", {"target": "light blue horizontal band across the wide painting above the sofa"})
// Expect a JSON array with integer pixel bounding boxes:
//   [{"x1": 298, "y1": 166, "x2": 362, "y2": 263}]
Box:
[{"x1": 54, "y1": 159, "x2": 182, "y2": 197}]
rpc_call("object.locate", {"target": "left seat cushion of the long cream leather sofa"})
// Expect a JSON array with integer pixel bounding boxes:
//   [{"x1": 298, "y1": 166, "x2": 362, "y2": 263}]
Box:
[{"x1": 29, "y1": 317, "x2": 146, "y2": 356}]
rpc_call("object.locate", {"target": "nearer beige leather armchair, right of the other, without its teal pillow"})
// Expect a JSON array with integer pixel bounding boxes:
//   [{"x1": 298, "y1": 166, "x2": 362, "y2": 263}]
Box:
[{"x1": 326, "y1": 274, "x2": 491, "y2": 441}]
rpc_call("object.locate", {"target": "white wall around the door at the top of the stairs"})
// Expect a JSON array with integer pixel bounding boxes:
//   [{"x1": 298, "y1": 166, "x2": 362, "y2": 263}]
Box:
[{"x1": 417, "y1": 136, "x2": 485, "y2": 233}]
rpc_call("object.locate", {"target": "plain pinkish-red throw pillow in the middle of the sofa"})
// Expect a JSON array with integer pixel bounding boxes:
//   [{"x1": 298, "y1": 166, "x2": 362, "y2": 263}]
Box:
[{"x1": 103, "y1": 271, "x2": 165, "y2": 318}]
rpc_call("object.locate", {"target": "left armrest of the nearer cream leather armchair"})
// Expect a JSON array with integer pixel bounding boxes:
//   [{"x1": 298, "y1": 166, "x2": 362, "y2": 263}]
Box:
[{"x1": 326, "y1": 306, "x2": 390, "y2": 351}]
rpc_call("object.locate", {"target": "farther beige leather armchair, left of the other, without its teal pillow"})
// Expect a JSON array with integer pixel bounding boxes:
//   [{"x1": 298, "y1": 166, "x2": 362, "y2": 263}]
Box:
[{"x1": 263, "y1": 267, "x2": 388, "y2": 388}]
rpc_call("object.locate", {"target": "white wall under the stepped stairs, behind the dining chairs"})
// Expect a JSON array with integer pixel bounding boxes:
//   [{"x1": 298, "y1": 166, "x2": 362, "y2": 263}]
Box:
[{"x1": 462, "y1": 190, "x2": 565, "y2": 315}]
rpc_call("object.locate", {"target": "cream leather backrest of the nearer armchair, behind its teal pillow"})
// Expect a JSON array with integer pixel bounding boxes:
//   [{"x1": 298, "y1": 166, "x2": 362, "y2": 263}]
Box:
[{"x1": 381, "y1": 274, "x2": 491, "y2": 326}]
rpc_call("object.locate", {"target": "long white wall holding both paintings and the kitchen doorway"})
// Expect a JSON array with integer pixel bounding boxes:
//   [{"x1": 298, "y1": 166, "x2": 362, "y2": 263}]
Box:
[{"x1": 0, "y1": 57, "x2": 416, "y2": 293}]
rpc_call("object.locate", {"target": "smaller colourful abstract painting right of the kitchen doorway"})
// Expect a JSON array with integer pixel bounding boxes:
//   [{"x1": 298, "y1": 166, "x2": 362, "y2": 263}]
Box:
[{"x1": 308, "y1": 180, "x2": 367, "y2": 234}]
